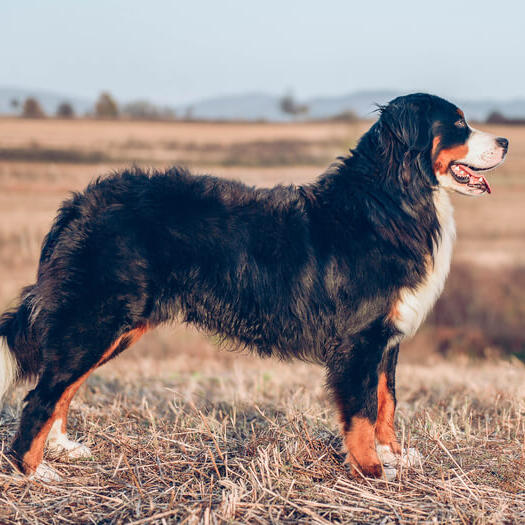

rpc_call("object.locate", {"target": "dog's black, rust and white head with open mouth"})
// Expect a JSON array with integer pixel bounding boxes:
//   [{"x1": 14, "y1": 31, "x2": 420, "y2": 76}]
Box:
[{"x1": 378, "y1": 93, "x2": 508, "y2": 195}]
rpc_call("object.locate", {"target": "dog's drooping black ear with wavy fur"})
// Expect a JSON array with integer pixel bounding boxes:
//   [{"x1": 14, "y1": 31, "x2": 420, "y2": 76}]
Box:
[{"x1": 379, "y1": 97, "x2": 433, "y2": 187}]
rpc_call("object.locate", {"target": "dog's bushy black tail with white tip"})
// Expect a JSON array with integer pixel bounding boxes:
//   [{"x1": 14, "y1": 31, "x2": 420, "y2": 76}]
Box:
[{"x1": 0, "y1": 288, "x2": 40, "y2": 406}]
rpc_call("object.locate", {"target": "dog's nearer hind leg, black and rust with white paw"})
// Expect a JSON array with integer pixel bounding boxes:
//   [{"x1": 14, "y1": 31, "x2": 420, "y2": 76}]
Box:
[{"x1": 11, "y1": 326, "x2": 147, "y2": 480}]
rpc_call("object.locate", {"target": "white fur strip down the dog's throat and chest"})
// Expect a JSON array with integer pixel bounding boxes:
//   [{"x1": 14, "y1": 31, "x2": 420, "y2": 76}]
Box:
[{"x1": 392, "y1": 188, "x2": 456, "y2": 338}]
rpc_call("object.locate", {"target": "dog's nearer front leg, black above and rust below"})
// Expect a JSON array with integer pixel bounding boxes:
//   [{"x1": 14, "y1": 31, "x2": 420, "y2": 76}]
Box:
[{"x1": 327, "y1": 326, "x2": 391, "y2": 477}]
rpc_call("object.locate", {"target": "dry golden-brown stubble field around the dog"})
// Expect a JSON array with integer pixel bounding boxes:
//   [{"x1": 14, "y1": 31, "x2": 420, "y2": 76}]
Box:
[{"x1": 0, "y1": 118, "x2": 525, "y2": 524}]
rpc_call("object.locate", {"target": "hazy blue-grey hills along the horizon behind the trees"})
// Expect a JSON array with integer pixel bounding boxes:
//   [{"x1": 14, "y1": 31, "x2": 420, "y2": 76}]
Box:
[{"x1": 0, "y1": 87, "x2": 525, "y2": 121}]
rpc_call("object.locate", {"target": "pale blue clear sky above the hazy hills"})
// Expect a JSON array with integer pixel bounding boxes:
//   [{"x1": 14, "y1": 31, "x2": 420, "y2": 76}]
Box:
[{"x1": 0, "y1": 0, "x2": 525, "y2": 105}]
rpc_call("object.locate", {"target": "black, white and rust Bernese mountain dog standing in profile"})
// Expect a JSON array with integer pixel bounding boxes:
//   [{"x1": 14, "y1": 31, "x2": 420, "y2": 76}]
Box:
[{"x1": 0, "y1": 93, "x2": 508, "y2": 480}]
